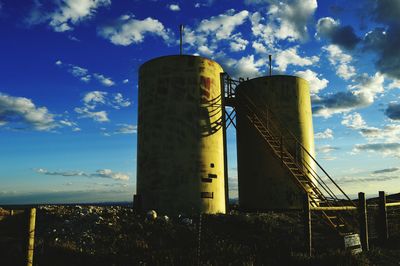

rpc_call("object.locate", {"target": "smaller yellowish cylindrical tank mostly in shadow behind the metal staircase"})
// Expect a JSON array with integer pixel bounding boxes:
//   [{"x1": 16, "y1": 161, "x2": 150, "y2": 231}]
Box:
[{"x1": 237, "y1": 75, "x2": 315, "y2": 210}]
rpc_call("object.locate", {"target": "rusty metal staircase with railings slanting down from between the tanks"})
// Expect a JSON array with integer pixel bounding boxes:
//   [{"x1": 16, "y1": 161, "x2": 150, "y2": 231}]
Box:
[{"x1": 224, "y1": 76, "x2": 356, "y2": 235}]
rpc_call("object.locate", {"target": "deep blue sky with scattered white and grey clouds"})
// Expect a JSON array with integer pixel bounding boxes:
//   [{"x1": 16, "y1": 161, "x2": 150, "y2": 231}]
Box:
[{"x1": 0, "y1": 0, "x2": 400, "y2": 204}]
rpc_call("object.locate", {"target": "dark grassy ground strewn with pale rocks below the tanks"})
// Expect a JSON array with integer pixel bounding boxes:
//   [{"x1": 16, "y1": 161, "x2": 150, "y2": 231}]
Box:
[{"x1": 0, "y1": 205, "x2": 400, "y2": 265}]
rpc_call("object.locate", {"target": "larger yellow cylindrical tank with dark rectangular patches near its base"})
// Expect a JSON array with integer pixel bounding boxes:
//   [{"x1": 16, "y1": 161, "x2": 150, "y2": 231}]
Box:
[{"x1": 137, "y1": 55, "x2": 225, "y2": 214}]
